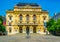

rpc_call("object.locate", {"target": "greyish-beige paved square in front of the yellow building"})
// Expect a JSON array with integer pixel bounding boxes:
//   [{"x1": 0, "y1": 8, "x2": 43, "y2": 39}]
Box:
[{"x1": 0, "y1": 35, "x2": 60, "y2": 42}]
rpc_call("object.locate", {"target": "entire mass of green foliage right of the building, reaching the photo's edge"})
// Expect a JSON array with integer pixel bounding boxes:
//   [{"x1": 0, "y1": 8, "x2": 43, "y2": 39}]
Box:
[{"x1": 46, "y1": 19, "x2": 60, "y2": 32}]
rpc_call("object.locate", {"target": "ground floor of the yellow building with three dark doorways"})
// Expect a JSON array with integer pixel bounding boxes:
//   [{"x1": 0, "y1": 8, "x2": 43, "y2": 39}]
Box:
[{"x1": 6, "y1": 25, "x2": 45, "y2": 34}]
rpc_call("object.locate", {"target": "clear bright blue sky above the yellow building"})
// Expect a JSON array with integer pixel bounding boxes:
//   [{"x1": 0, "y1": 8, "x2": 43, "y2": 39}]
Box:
[{"x1": 0, "y1": 0, "x2": 60, "y2": 17}]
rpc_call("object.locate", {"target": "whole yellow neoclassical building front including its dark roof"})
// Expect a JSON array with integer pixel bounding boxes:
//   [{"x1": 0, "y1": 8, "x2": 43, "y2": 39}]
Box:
[{"x1": 6, "y1": 3, "x2": 49, "y2": 35}]
